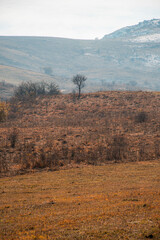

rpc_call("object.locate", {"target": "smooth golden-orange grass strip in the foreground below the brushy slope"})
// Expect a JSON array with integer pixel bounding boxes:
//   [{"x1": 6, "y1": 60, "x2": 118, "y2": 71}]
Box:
[{"x1": 0, "y1": 161, "x2": 160, "y2": 240}]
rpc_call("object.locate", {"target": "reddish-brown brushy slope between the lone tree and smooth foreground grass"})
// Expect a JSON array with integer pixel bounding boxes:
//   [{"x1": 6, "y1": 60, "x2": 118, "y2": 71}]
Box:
[{"x1": 0, "y1": 92, "x2": 160, "y2": 175}]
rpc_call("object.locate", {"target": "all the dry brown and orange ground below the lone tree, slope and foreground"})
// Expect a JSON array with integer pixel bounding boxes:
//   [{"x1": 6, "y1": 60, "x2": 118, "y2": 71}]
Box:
[{"x1": 0, "y1": 92, "x2": 160, "y2": 240}]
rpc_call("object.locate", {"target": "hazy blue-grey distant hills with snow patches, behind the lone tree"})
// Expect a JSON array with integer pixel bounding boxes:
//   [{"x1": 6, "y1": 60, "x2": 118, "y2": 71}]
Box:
[{"x1": 0, "y1": 19, "x2": 160, "y2": 96}]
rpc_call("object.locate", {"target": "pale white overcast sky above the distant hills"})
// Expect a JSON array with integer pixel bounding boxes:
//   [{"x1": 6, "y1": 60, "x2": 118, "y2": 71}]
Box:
[{"x1": 0, "y1": 0, "x2": 160, "y2": 39}]
